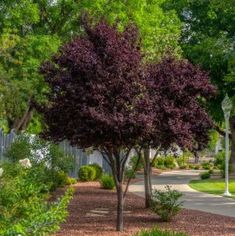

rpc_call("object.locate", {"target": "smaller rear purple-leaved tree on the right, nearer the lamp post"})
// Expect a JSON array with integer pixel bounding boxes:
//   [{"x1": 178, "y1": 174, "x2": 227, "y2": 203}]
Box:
[{"x1": 140, "y1": 57, "x2": 216, "y2": 207}]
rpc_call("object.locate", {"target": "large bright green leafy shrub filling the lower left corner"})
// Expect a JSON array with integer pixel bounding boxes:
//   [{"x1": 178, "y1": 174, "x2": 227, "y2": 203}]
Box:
[{"x1": 0, "y1": 163, "x2": 73, "y2": 236}]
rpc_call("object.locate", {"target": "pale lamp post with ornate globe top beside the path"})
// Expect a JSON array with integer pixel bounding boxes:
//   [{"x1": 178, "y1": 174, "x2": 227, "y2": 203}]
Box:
[{"x1": 222, "y1": 94, "x2": 232, "y2": 197}]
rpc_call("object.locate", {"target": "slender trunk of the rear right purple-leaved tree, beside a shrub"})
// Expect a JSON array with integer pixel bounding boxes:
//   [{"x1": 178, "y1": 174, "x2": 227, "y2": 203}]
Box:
[{"x1": 144, "y1": 148, "x2": 152, "y2": 208}]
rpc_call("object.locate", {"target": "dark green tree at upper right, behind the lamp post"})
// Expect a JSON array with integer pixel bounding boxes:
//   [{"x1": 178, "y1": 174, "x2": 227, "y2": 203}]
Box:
[{"x1": 164, "y1": 0, "x2": 235, "y2": 171}]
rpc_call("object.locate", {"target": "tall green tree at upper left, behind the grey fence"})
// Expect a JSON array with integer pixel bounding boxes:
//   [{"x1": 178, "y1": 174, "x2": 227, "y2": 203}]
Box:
[{"x1": 0, "y1": 0, "x2": 81, "y2": 131}]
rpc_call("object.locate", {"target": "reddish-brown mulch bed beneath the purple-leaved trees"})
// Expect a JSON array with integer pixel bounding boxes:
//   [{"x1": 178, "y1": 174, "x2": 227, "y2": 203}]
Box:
[{"x1": 55, "y1": 182, "x2": 235, "y2": 236}]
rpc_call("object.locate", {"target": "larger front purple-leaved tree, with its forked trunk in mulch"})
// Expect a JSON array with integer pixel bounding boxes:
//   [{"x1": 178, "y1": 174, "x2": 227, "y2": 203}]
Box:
[{"x1": 41, "y1": 18, "x2": 154, "y2": 231}]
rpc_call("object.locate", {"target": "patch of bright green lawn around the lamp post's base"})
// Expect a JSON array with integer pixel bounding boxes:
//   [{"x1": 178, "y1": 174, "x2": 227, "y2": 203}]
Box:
[{"x1": 189, "y1": 179, "x2": 235, "y2": 198}]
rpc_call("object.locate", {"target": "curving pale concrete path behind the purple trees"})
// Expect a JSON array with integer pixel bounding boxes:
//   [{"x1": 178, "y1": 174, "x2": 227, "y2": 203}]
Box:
[{"x1": 129, "y1": 170, "x2": 235, "y2": 217}]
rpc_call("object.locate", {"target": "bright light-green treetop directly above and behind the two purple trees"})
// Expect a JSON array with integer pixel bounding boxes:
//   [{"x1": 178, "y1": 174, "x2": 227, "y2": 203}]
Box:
[{"x1": 80, "y1": 0, "x2": 181, "y2": 60}]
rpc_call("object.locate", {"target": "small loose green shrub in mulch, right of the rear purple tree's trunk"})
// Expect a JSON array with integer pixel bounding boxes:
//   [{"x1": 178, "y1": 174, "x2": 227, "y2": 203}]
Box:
[{"x1": 151, "y1": 186, "x2": 182, "y2": 221}]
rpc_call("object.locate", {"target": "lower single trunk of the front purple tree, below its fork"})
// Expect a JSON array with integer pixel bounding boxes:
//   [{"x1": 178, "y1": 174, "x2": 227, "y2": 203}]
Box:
[{"x1": 116, "y1": 183, "x2": 124, "y2": 231}]
